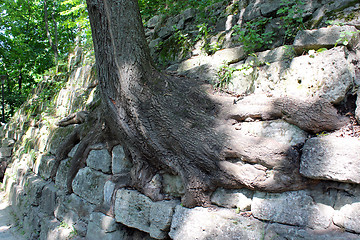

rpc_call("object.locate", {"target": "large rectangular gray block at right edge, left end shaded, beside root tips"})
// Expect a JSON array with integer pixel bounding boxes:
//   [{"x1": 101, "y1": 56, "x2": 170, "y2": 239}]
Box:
[{"x1": 300, "y1": 135, "x2": 360, "y2": 184}]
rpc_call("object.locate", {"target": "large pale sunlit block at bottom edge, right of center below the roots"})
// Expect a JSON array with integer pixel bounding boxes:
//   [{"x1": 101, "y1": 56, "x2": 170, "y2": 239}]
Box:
[{"x1": 169, "y1": 206, "x2": 265, "y2": 240}]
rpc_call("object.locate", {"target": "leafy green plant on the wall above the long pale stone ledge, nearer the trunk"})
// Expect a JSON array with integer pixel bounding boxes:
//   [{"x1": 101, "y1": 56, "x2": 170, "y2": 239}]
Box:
[{"x1": 233, "y1": 17, "x2": 275, "y2": 53}]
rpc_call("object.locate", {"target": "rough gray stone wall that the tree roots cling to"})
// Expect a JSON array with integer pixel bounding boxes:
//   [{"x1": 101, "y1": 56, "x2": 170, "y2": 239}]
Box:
[{"x1": 0, "y1": 0, "x2": 360, "y2": 240}]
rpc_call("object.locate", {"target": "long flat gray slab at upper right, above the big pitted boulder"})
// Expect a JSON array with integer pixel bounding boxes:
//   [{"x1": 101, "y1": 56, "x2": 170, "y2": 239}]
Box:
[{"x1": 294, "y1": 26, "x2": 359, "y2": 52}]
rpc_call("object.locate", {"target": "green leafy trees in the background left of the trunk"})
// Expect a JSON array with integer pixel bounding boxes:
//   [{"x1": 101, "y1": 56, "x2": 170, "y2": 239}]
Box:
[{"x1": 0, "y1": 0, "x2": 77, "y2": 119}]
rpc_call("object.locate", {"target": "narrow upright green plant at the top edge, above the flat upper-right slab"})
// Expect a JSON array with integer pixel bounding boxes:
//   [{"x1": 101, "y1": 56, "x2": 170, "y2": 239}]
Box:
[{"x1": 277, "y1": 0, "x2": 305, "y2": 44}]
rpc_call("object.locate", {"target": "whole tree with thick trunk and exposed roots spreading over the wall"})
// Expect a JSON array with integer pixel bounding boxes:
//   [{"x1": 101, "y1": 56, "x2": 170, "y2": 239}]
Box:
[{"x1": 51, "y1": 0, "x2": 346, "y2": 207}]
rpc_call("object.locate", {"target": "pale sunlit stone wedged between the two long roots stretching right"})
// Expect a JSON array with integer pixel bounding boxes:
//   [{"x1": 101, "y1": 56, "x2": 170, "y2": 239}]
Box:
[{"x1": 237, "y1": 120, "x2": 308, "y2": 145}]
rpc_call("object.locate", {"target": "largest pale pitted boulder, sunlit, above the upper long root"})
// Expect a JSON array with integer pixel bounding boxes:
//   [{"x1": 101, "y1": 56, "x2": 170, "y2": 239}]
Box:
[{"x1": 252, "y1": 47, "x2": 355, "y2": 104}]
